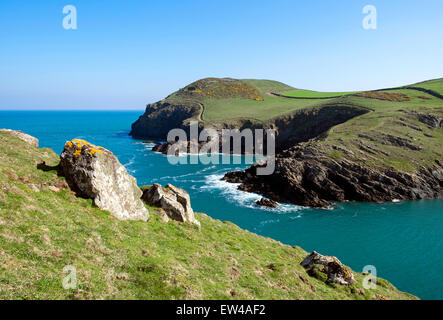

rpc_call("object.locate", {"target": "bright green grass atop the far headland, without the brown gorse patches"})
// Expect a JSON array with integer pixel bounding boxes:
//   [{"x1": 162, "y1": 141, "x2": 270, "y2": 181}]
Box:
[{"x1": 167, "y1": 79, "x2": 443, "y2": 124}]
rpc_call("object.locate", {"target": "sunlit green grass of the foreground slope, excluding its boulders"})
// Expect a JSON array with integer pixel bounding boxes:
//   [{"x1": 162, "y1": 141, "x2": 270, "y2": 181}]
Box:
[{"x1": 0, "y1": 134, "x2": 414, "y2": 299}]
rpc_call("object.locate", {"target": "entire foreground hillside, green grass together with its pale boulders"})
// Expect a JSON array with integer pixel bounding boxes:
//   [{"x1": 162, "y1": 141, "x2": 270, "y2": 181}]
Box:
[{"x1": 0, "y1": 132, "x2": 416, "y2": 300}]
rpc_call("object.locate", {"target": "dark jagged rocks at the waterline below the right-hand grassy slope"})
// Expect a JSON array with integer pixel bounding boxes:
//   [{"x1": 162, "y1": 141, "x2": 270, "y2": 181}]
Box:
[{"x1": 223, "y1": 141, "x2": 443, "y2": 208}]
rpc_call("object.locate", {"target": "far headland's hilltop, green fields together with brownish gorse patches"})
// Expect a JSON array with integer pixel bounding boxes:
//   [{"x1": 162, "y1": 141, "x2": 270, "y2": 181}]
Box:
[{"x1": 158, "y1": 78, "x2": 443, "y2": 123}]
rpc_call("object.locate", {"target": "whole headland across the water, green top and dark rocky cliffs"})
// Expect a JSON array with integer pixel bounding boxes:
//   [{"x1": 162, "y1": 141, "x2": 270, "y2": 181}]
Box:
[{"x1": 131, "y1": 78, "x2": 443, "y2": 208}]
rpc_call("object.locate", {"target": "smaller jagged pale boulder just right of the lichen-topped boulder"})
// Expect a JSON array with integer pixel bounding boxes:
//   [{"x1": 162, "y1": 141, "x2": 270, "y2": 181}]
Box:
[{"x1": 142, "y1": 183, "x2": 200, "y2": 226}]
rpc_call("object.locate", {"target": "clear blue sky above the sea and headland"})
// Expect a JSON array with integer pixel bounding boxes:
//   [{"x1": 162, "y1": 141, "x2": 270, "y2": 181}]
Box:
[{"x1": 0, "y1": 0, "x2": 443, "y2": 109}]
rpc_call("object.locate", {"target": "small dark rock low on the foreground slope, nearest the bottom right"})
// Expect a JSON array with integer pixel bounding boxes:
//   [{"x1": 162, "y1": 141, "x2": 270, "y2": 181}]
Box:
[{"x1": 300, "y1": 251, "x2": 355, "y2": 286}]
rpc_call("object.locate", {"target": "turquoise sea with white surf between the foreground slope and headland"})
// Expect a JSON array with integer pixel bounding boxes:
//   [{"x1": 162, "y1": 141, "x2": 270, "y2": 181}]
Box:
[{"x1": 0, "y1": 111, "x2": 443, "y2": 299}]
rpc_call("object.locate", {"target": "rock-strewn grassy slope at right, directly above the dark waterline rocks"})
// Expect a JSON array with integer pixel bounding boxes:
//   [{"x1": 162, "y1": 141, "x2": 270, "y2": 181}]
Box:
[{"x1": 319, "y1": 90, "x2": 443, "y2": 172}]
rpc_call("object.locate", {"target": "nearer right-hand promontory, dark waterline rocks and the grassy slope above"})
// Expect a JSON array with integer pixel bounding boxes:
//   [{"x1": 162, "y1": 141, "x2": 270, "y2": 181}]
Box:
[{"x1": 224, "y1": 104, "x2": 443, "y2": 207}]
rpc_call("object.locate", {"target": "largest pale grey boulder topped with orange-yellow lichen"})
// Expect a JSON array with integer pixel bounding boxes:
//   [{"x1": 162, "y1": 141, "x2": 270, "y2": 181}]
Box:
[{"x1": 60, "y1": 139, "x2": 149, "y2": 220}]
